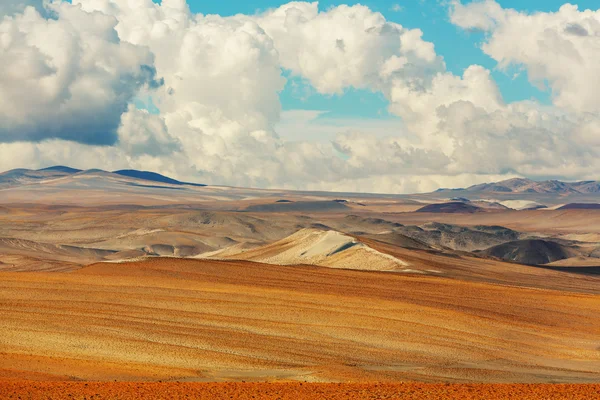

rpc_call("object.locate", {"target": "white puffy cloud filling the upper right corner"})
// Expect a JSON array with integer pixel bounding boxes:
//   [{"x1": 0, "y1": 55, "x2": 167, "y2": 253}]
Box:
[{"x1": 451, "y1": 0, "x2": 600, "y2": 113}]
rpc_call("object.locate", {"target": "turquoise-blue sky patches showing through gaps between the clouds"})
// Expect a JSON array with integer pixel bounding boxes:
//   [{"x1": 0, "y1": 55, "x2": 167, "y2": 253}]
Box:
[{"x1": 154, "y1": 0, "x2": 598, "y2": 119}]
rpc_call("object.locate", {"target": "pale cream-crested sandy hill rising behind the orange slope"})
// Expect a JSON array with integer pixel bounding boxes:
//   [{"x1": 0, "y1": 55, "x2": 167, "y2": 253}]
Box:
[{"x1": 203, "y1": 229, "x2": 410, "y2": 272}]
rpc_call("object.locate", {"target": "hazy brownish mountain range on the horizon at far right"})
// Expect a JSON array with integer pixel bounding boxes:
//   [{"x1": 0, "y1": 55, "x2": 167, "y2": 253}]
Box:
[{"x1": 437, "y1": 178, "x2": 600, "y2": 194}]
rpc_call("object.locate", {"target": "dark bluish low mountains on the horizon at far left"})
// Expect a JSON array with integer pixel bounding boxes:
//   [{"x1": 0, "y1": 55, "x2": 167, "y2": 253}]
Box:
[{"x1": 0, "y1": 165, "x2": 206, "y2": 187}]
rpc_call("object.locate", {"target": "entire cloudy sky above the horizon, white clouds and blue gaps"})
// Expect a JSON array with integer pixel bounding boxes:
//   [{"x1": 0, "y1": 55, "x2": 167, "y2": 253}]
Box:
[{"x1": 0, "y1": 0, "x2": 600, "y2": 193}]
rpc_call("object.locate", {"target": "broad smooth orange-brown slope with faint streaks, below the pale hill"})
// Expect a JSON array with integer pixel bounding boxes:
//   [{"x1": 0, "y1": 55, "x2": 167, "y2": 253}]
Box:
[{"x1": 0, "y1": 259, "x2": 600, "y2": 383}]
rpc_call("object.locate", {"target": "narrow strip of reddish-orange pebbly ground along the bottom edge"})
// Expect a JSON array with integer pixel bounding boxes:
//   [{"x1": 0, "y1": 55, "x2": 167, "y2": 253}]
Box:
[{"x1": 0, "y1": 381, "x2": 600, "y2": 400}]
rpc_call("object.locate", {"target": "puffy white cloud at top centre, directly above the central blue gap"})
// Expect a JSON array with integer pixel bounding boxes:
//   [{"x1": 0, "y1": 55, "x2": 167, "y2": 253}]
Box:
[{"x1": 257, "y1": 2, "x2": 444, "y2": 94}]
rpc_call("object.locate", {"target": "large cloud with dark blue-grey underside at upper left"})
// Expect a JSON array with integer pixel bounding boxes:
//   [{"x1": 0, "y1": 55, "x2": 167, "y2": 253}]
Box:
[{"x1": 0, "y1": 3, "x2": 158, "y2": 145}]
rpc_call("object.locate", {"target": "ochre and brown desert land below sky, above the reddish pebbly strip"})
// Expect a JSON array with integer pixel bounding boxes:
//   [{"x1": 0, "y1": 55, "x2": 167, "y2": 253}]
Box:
[{"x1": 0, "y1": 168, "x2": 600, "y2": 398}]
